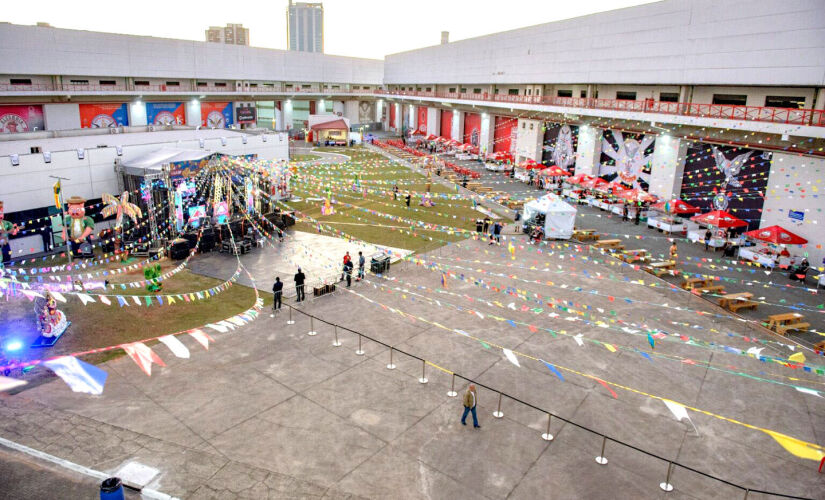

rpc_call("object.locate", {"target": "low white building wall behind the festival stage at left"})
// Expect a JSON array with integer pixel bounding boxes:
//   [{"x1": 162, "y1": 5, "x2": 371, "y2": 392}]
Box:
[{"x1": 0, "y1": 134, "x2": 289, "y2": 212}]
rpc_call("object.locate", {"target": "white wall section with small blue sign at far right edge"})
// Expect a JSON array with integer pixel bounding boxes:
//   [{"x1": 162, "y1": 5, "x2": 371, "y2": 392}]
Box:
[{"x1": 760, "y1": 152, "x2": 825, "y2": 267}]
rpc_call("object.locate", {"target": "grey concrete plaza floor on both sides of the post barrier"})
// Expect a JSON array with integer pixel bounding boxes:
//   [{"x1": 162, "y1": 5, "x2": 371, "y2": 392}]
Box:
[{"x1": 0, "y1": 231, "x2": 825, "y2": 499}]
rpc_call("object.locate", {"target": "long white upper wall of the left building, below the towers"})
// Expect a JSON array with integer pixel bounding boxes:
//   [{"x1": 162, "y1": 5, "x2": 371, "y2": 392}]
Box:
[{"x1": 0, "y1": 24, "x2": 384, "y2": 84}]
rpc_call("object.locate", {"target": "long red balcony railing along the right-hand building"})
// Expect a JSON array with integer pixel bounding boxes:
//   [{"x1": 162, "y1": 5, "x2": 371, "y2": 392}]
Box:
[{"x1": 375, "y1": 90, "x2": 825, "y2": 127}]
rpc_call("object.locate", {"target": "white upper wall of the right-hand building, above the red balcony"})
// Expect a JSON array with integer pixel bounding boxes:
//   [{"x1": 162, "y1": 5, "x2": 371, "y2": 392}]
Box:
[{"x1": 384, "y1": 0, "x2": 825, "y2": 86}]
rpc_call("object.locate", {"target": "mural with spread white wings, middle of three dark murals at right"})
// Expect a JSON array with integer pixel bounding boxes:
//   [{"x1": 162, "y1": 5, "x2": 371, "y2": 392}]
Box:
[{"x1": 599, "y1": 130, "x2": 656, "y2": 190}]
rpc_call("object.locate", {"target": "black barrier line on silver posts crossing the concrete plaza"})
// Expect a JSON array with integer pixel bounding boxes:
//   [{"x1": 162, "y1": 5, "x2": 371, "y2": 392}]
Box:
[{"x1": 276, "y1": 298, "x2": 807, "y2": 500}]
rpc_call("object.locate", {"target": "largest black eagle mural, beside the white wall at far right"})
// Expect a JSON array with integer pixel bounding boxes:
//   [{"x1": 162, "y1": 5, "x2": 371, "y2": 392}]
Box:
[{"x1": 681, "y1": 142, "x2": 773, "y2": 230}]
